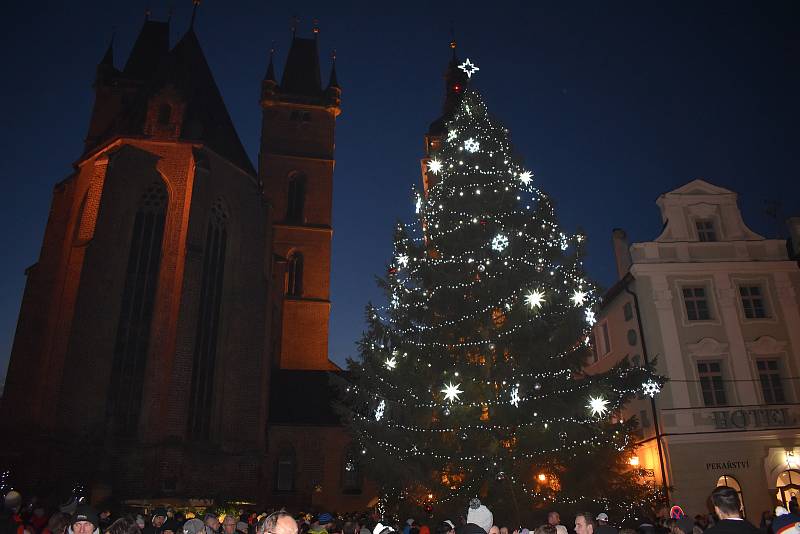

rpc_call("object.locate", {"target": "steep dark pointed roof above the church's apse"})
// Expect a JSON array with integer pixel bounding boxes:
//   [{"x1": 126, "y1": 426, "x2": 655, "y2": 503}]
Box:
[{"x1": 87, "y1": 20, "x2": 255, "y2": 174}]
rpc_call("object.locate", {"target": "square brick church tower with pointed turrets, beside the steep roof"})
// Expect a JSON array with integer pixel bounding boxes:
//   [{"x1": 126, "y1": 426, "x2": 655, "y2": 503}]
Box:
[{"x1": 259, "y1": 27, "x2": 341, "y2": 370}]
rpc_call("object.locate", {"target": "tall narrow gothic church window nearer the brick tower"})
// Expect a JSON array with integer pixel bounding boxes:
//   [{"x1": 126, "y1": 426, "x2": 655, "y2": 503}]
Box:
[{"x1": 189, "y1": 200, "x2": 228, "y2": 439}]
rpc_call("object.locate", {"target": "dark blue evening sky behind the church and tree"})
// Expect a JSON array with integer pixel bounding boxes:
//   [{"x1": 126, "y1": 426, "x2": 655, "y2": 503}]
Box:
[{"x1": 0, "y1": 0, "x2": 800, "y2": 377}]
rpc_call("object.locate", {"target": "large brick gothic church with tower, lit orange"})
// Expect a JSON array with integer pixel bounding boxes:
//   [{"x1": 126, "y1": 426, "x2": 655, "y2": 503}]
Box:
[{"x1": 0, "y1": 12, "x2": 376, "y2": 511}]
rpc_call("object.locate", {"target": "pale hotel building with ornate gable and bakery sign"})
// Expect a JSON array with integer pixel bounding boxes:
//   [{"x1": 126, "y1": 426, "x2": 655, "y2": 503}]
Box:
[{"x1": 585, "y1": 180, "x2": 800, "y2": 523}]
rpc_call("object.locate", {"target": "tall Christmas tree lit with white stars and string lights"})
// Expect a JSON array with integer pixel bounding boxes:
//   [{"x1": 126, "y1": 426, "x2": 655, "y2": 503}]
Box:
[{"x1": 342, "y1": 56, "x2": 662, "y2": 518}]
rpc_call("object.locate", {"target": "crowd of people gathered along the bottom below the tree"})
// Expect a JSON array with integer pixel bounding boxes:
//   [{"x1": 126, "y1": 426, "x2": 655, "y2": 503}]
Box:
[{"x1": 0, "y1": 486, "x2": 788, "y2": 534}]
